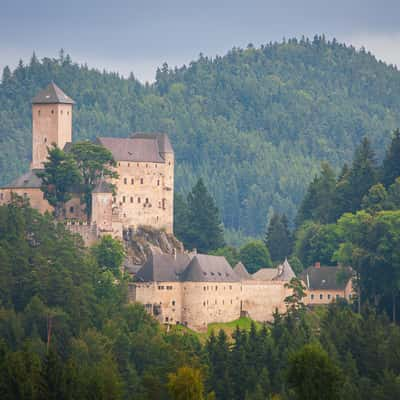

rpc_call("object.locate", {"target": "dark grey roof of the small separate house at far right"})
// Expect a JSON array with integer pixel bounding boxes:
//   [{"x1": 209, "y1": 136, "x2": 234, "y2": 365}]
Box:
[{"x1": 300, "y1": 266, "x2": 352, "y2": 290}]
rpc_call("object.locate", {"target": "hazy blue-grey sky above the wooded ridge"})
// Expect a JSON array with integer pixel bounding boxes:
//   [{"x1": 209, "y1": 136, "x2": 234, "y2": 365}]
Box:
[{"x1": 0, "y1": 0, "x2": 400, "y2": 81}]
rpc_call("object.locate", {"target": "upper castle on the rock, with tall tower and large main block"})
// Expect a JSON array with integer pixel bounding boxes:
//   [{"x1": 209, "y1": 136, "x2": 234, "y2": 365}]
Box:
[{"x1": 0, "y1": 82, "x2": 174, "y2": 244}]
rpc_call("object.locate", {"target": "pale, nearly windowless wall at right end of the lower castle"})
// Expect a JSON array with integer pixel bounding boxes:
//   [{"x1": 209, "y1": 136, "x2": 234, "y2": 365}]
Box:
[{"x1": 242, "y1": 280, "x2": 291, "y2": 321}]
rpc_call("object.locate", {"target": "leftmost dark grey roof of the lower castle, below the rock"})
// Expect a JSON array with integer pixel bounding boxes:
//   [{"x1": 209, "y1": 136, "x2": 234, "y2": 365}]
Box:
[{"x1": 136, "y1": 253, "x2": 190, "y2": 282}]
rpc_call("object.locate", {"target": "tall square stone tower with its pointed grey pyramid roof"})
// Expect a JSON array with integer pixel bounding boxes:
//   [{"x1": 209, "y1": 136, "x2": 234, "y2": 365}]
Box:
[{"x1": 31, "y1": 82, "x2": 75, "y2": 169}]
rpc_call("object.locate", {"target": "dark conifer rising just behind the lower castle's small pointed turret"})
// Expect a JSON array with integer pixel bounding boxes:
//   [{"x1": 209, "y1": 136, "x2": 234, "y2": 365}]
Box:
[{"x1": 264, "y1": 213, "x2": 292, "y2": 262}]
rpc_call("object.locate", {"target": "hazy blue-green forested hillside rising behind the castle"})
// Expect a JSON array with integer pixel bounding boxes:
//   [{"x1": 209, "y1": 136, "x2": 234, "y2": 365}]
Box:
[{"x1": 0, "y1": 37, "x2": 400, "y2": 235}]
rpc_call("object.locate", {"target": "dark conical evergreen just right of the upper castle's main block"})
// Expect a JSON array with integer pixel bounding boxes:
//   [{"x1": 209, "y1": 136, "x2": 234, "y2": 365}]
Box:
[{"x1": 185, "y1": 178, "x2": 225, "y2": 253}]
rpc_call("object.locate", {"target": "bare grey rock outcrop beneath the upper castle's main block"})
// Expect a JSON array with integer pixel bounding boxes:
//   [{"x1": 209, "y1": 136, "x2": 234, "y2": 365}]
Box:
[{"x1": 124, "y1": 226, "x2": 184, "y2": 265}]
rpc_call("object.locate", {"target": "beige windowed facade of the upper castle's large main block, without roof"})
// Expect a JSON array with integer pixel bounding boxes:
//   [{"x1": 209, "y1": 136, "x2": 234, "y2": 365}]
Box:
[{"x1": 113, "y1": 154, "x2": 174, "y2": 233}]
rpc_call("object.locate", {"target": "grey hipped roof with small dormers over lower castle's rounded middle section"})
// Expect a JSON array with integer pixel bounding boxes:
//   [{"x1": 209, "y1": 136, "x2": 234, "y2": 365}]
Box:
[{"x1": 182, "y1": 254, "x2": 240, "y2": 282}]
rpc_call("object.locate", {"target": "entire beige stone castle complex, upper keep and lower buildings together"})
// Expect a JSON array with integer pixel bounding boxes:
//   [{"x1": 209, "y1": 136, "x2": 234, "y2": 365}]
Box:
[{"x1": 0, "y1": 83, "x2": 352, "y2": 330}]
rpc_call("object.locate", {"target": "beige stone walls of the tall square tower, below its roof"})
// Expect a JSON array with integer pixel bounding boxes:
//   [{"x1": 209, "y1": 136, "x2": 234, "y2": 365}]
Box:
[{"x1": 31, "y1": 104, "x2": 72, "y2": 169}]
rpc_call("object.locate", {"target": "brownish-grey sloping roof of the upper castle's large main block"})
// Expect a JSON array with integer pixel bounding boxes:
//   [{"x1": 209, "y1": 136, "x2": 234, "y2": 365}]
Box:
[{"x1": 97, "y1": 137, "x2": 165, "y2": 163}]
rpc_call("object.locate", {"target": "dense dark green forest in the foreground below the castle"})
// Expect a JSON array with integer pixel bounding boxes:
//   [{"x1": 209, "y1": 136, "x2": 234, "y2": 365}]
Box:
[{"x1": 0, "y1": 199, "x2": 400, "y2": 400}]
